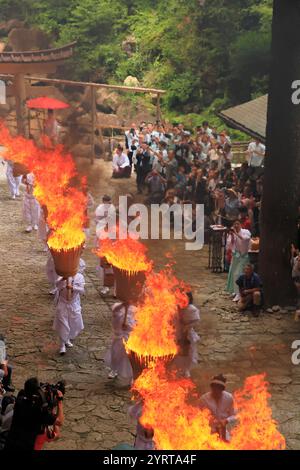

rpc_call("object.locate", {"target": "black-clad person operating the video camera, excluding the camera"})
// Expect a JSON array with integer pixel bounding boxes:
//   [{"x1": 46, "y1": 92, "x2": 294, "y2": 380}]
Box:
[{"x1": 5, "y1": 378, "x2": 57, "y2": 451}]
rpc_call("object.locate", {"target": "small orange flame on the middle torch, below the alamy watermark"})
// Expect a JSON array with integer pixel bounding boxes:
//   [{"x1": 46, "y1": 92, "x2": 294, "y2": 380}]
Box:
[{"x1": 96, "y1": 235, "x2": 153, "y2": 274}]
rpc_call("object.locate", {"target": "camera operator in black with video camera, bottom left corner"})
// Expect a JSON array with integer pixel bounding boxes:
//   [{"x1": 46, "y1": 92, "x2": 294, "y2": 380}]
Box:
[{"x1": 4, "y1": 378, "x2": 65, "y2": 451}]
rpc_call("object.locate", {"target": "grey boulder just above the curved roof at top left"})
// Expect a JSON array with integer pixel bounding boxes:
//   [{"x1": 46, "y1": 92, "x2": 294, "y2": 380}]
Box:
[{"x1": 7, "y1": 28, "x2": 50, "y2": 52}]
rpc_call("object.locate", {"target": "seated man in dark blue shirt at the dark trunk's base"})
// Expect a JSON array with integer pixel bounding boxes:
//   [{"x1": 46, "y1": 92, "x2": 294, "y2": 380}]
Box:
[{"x1": 236, "y1": 264, "x2": 263, "y2": 316}]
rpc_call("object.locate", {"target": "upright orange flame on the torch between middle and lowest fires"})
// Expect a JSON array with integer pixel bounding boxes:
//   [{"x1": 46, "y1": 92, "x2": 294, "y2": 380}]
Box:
[{"x1": 126, "y1": 270, "x2": 188, "y2": 358}]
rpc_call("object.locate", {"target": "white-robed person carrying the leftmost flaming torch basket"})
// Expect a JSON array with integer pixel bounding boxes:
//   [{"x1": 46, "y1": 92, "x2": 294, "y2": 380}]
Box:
[{"x1": 53, "y1": 259, "x2": 85, "y2": 355}]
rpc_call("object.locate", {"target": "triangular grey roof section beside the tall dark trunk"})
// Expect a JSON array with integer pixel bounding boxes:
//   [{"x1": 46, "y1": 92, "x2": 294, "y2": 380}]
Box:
[{"x1": 219, "y1": 95, "x2": 268, "y2": 140}]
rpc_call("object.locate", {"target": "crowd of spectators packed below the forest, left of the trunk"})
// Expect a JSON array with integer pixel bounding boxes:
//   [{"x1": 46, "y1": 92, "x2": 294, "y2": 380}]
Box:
[{"x1": 113, "y1": 121, "x2": 265, "y2": 237}]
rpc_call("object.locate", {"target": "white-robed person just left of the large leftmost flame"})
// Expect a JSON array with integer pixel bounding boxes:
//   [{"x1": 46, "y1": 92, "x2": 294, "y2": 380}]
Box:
[{"x1": 22, "y1": 173, "x2": 40, "y2": 233}]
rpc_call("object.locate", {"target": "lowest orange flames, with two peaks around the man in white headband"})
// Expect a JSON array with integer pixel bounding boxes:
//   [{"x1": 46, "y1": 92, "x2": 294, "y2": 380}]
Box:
[{"x1": 133, "y1": 362, "x2": 285, "y2": 450}]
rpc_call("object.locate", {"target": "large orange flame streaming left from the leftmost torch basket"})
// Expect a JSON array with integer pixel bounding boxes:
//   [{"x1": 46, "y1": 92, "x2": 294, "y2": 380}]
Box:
[{"x1": 0, "y1": 123, "x2": 86, "y2": 251}]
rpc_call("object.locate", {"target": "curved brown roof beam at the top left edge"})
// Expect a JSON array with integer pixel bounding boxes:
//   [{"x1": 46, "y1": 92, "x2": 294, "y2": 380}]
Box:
[{"x1": 0, "y1": 42, "x2": 76, "y2": 64}]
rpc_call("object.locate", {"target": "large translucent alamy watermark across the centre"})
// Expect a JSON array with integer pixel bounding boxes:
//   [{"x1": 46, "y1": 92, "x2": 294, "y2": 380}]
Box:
[{"x1": 97, "y1": 196, "x2": 204, "y2": 251}]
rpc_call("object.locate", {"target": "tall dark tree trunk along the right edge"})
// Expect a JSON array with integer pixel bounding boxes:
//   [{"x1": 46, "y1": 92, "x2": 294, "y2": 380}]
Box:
[{"x1": 260, "y1": 0, "x2": 300, "y2": 305}]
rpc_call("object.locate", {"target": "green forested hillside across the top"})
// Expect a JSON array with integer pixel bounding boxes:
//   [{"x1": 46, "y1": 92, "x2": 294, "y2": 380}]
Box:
[{"x1": 0, "y1": 0, "x2": 272, "y2": 130}]
